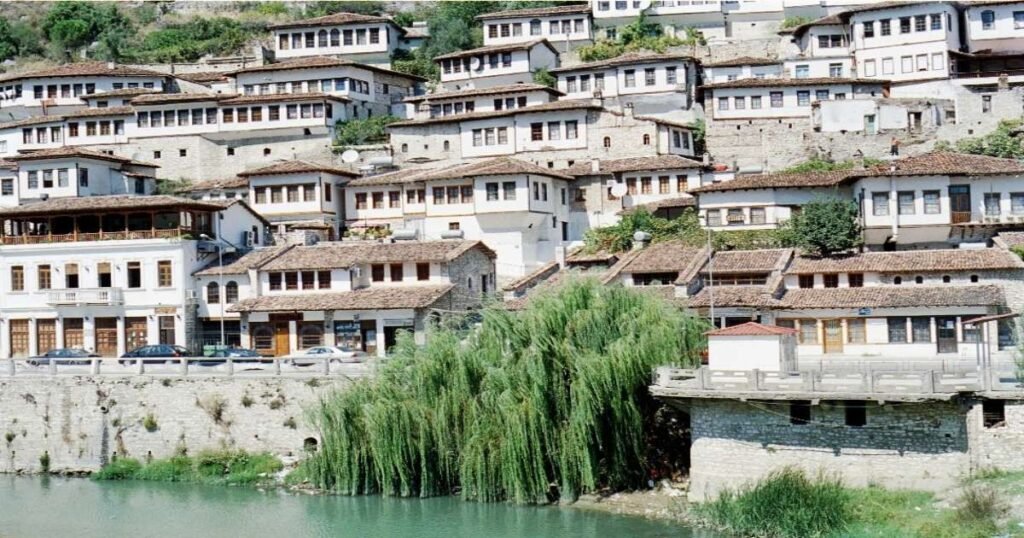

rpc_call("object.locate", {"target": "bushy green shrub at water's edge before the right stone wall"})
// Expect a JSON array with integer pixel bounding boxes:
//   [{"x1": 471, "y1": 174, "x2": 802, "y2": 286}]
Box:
[{"x1": 696, "y1": 468, "x2": 853, "y2": 538}]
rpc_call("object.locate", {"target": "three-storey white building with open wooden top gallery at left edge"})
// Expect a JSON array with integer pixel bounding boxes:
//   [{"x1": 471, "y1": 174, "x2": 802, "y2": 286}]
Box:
[{"x1": 0, "y1": 195, "x2": 263, "y2": 357}]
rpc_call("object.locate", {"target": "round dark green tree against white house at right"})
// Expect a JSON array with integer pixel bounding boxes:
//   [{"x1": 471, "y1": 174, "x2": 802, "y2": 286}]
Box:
[{"x1": 781, "y1": 198, "x2": 862, "y2": 256}]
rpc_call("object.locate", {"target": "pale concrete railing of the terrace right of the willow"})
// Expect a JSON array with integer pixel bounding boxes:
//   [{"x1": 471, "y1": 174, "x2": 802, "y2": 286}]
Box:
[{"x1": 651, "y1": 367, "x2": 1022, "y2": 396}]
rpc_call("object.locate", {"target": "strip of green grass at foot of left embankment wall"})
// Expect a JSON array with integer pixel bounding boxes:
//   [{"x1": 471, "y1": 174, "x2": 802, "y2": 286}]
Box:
[{"x1": 92, "y1": 451, "x2": 284, "y2": 486}]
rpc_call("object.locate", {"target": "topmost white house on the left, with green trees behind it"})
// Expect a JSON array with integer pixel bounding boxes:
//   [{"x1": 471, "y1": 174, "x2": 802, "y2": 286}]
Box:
[{"x1": 269, "y1": 13, "x2": 406, "y2": 66}]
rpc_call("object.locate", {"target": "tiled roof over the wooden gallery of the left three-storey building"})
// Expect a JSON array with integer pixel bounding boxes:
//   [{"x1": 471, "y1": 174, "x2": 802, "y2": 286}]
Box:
[{"x1": 0, "y1": 195, "x2": 222, "y2": 217}]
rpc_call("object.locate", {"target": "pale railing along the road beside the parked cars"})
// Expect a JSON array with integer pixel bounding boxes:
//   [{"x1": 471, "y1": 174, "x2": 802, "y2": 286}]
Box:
[{"x1": 0, "y1": 357, "x2": 378, "y2": 378}]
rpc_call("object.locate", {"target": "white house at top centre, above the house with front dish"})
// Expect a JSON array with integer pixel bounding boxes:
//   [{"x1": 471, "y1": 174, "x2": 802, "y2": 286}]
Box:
[{"x1": 476, "y1": 4, "x2": 593, "y2": 52}]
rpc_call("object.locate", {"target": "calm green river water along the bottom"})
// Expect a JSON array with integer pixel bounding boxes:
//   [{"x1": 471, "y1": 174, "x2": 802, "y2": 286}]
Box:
[{"x1": 0, "y1": 475, "x2": 706, "y2": 538}]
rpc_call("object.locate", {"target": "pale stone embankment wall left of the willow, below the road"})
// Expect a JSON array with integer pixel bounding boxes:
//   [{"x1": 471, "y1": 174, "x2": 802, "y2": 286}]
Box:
[{"x1": 0, "y1": 376, "x2": 344, "y2": 472}]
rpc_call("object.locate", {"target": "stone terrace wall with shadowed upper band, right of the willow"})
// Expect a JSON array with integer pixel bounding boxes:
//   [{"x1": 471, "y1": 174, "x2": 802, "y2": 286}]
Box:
[{"x1": 689, "y1": 400, "x2": 966, "y2": 500}]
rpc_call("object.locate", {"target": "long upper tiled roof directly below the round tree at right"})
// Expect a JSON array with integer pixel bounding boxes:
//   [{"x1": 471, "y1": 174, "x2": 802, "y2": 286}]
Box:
[{"x1": 785, "y1": 248, "x2": 1024, "y2": 275}]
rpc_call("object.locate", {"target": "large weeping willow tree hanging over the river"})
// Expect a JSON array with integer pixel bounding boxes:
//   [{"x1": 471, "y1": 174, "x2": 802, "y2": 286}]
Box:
[{"x1": 306, "y1": 280, "x2": 706, "y2": 503}]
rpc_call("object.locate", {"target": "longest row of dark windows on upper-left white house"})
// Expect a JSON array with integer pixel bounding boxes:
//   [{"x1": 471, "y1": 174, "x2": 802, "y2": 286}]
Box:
[{"x1": 136, "y1": 102, "x2": 334, "y2": 128}]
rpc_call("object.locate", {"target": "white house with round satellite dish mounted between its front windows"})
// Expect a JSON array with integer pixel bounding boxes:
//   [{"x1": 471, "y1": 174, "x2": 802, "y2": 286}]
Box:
[{"x1": 433, "y1": 38, "x2": 558, "y2": 90}]
